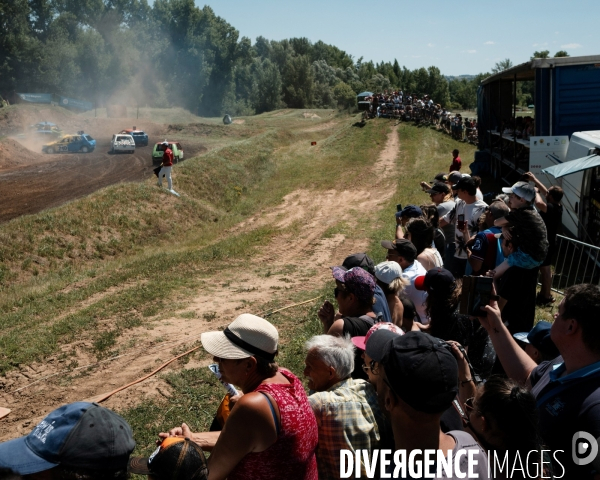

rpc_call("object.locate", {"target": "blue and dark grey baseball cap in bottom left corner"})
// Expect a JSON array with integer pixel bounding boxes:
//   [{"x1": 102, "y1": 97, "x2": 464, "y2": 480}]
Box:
[{"x1": 0, "y1": 402, "x2": 135, "y2": 475}]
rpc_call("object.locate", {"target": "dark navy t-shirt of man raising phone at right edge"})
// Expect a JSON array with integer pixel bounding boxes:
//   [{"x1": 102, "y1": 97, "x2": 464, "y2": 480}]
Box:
[{"x1": 530, "y1": 357, "x2": 600, "y2": 480}]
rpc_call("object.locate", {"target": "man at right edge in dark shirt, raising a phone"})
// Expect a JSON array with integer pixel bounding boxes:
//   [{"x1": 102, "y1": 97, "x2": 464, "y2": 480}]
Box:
[{"x1": 481, "y1": 284, "x2": 600, "y2": 479}]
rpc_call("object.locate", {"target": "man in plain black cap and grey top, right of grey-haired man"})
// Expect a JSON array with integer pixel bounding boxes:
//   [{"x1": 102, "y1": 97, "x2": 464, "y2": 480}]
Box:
[{"x1": 367, "y1": 331, "x2": 489, "y2": 479}]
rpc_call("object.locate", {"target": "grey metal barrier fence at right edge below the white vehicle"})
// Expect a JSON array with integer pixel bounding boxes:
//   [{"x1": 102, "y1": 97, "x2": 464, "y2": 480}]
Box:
[{"x1": 552, "y1": 235, "x2": 600, "y2": 294}]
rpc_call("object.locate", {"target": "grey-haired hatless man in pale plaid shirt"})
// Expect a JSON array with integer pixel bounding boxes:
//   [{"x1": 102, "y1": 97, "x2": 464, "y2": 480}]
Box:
[{"x1": 304, "y1": 336, "x2": 391, "y2": 479}]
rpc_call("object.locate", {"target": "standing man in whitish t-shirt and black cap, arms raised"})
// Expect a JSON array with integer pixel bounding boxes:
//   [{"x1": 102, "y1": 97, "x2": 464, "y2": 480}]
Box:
[{"x1": 440, "y1": 177, "x2": 487, "y2": 278}]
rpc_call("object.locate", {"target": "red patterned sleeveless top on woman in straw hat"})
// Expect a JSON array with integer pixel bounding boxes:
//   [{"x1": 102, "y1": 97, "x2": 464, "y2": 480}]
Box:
[{"x1": 227, "y1": 368, "x2": 319, "y2": 480}]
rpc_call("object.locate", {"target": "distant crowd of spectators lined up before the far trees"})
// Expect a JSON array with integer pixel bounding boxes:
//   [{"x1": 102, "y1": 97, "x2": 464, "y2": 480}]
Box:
[{"x1": 363, "y1": 90, "x2": 478, "y2": 144}]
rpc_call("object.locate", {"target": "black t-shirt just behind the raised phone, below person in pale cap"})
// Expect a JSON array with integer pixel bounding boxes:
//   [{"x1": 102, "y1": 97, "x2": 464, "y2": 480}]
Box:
[{"x1": 498, "y1": 267, "x2": 539, "y2": 334}]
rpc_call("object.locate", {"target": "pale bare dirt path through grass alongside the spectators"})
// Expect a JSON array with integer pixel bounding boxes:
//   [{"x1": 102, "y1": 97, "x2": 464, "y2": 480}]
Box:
[{"x1": 0, "y1": 125, "x2": 399, "y2": 441}]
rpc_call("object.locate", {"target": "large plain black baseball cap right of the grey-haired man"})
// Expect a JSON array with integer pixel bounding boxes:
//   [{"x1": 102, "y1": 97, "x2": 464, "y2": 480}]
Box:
[{"x1": 382, "y1": 332, "x2": 458, "y2": 414}]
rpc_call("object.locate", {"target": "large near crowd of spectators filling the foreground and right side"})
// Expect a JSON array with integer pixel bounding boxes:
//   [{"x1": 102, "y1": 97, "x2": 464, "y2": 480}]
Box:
[{"x1": 0, "y1": 156, "x2": 600, "y2": 480}]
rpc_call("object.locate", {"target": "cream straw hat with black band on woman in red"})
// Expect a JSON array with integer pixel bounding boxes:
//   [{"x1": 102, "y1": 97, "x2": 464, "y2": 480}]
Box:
[{"x1": 200, "y1": 313, "x2": 279, "y2": 362}]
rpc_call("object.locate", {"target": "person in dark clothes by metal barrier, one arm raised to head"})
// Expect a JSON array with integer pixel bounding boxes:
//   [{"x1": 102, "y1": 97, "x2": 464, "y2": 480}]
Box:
[{"x1": 525, "y1": 172, "x2": 564, "y2": 305}]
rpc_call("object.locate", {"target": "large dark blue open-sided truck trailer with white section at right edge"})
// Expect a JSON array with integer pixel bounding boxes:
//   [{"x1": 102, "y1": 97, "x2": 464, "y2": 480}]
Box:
[{"x1": 472, "y1": 55, "x2": 600, "y2": 244}]
